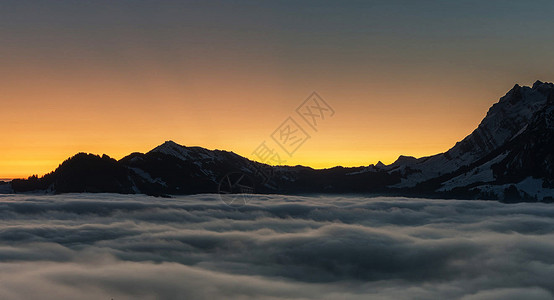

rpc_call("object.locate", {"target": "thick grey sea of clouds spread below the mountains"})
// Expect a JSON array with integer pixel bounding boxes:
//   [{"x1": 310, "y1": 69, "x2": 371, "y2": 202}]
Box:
[{"x1": 0, "y1": 194, "x2": 554, "y2": 300}]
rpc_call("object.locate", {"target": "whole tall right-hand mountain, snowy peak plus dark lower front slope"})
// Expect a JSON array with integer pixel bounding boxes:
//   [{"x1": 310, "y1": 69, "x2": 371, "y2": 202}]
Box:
[{"x1": 387, "y1": 81, "x2": 554, "y2": 199}]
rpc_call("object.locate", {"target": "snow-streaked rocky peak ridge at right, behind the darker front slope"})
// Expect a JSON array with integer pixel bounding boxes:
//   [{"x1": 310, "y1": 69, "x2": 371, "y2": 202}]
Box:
[{"x1": 388, "y1": 81, "x2": 554, "y2": 188}]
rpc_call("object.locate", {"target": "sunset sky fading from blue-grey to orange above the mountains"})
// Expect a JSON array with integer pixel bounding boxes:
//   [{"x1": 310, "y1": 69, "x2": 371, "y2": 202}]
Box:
[{"x1": 0, "y1": 0, "x2": 554, "y2": 178}]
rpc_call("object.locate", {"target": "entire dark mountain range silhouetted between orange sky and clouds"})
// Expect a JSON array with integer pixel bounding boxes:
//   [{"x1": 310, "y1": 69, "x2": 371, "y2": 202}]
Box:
[{"x1": 7, "y1": 81, "x2": 554, "y2": 201}]
